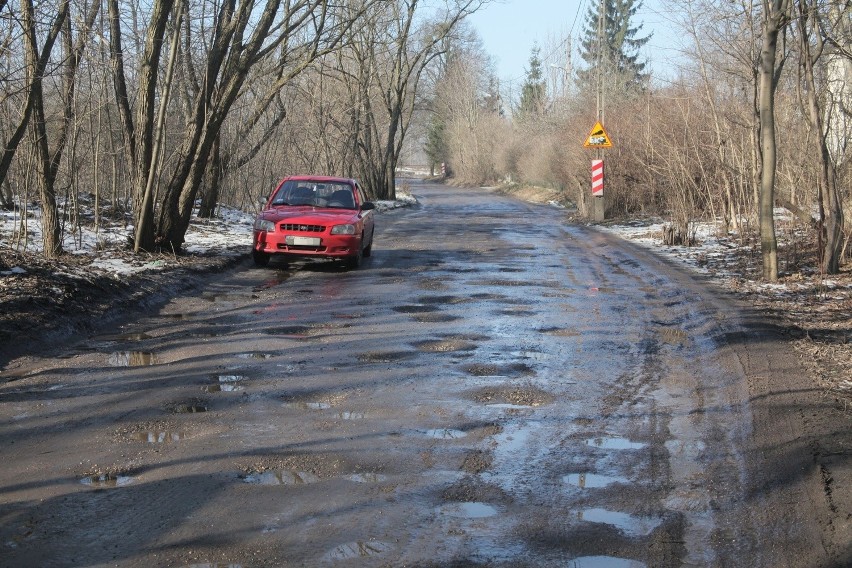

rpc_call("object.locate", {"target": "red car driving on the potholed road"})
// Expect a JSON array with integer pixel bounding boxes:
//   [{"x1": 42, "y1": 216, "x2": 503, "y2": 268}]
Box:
[{"x1": 252, "y1": 176, "x2": 375, "y2": 268}]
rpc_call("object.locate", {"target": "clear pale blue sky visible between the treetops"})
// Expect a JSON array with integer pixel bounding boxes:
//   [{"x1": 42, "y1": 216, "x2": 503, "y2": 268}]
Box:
[{"x1": 468, "y1": 0, "x2": 677, "y2": 85}]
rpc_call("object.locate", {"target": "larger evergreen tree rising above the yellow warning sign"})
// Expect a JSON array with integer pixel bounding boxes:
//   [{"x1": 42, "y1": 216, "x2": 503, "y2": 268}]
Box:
[{"x1": 577, "y1": 0, "x2": 651, "y2": 93}]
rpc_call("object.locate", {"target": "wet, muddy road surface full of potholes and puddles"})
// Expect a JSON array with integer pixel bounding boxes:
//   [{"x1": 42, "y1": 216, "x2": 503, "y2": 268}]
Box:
[{"x1": 0, "y1": 183, "x2": 840, "y2": 568}]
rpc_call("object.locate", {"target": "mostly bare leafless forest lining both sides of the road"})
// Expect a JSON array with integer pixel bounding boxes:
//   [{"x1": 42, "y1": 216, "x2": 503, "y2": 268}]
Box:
[{"x1": 0, "y1": 0, "x2": 852, "y2": 281}]
